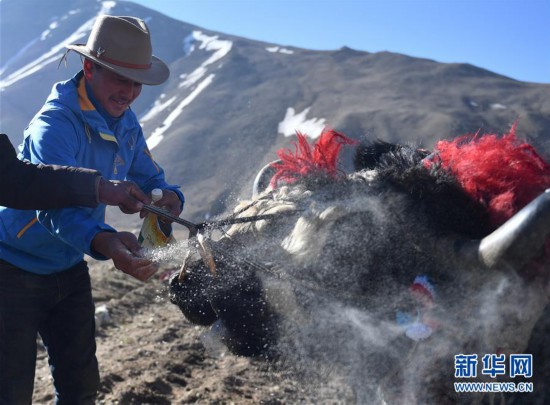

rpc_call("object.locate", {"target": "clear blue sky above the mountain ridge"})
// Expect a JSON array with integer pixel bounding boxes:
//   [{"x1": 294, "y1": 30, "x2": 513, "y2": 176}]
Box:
[{"x1": 130, "y1": 0, "x2": 550, "y2": 83}]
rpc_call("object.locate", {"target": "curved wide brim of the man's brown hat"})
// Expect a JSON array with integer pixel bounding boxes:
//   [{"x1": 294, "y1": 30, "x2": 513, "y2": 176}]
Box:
[{"x1": 67, "y1": 44, "x2": 170, "y2": 86}]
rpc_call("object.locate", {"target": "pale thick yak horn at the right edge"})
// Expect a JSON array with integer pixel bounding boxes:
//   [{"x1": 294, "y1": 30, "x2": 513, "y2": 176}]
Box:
[{"x1": 478, "y1": 189, "x2": 550, "y2": 270}]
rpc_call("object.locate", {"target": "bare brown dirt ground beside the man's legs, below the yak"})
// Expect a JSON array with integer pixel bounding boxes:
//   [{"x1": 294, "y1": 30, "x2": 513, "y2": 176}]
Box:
[{"x1": 33, "y1": 251, "x2": 353, "y2": 404}]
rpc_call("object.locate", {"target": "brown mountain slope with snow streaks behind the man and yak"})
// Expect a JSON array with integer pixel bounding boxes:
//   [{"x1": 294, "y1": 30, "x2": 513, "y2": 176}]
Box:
[{"x1": 0, "y1": 0, "x2": 550, "y2": 225}]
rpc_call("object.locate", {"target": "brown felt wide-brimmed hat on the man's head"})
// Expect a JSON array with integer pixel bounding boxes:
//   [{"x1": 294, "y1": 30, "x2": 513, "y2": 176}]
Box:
[{"x1": 67, "y1": 15, "x2": 170, "y2": 85}]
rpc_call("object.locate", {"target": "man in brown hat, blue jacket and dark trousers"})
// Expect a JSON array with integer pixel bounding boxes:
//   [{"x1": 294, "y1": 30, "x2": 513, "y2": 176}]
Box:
[{"x1": 0, "y1": 15, "x2": 184, "y2": 404}]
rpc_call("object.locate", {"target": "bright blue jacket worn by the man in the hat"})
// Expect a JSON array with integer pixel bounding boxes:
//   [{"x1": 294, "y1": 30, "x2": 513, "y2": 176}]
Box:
[{"x1": 0, "y1": 71, "x2": 184, "y2": 274}]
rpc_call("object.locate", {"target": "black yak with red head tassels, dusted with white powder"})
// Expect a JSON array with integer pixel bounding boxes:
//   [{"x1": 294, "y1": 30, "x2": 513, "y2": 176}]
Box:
[{"x1": 170, "y1": 128, "x2": 550, "y2": 403}]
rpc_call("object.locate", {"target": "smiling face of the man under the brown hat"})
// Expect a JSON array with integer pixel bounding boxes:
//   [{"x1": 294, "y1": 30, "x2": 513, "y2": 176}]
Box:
[{"x1": 84, "y1": 63, "x2": 142, "y2": 117}]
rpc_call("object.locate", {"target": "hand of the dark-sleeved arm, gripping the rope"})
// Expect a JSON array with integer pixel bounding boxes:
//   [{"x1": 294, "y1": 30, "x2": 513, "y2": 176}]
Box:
[{"x1": 98, "y1": 177, "x2": 151, "y2": 214}]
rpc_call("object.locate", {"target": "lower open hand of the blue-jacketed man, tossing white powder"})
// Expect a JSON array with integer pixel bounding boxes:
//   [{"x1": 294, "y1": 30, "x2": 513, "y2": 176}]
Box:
[{"x1": 92, "y1": 232, "x2": 158, "y2": 281}]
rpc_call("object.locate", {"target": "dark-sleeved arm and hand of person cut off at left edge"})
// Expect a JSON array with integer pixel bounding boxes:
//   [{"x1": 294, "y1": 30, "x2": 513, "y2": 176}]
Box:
[{"x1": 0, "y1": 134, "x2": 151, "y2": 210}]
